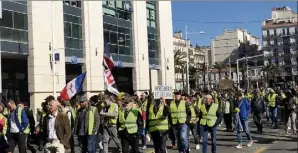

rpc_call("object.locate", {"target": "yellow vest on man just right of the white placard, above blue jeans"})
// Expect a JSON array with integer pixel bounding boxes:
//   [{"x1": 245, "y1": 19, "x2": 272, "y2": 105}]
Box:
[{"x1": 170, "y1": 100, "x2": 186, "y2": 125}]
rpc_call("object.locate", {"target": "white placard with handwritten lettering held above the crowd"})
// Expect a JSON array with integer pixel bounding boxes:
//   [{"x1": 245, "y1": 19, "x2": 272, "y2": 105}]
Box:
[{"x1": 154, "y1": 85, "x2": 173, "y2": 99}]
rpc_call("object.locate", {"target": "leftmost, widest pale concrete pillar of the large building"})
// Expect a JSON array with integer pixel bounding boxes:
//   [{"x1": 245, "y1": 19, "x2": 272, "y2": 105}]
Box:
[{"x1": 27, "y1": 1, "x2": 65, "y2": 111}]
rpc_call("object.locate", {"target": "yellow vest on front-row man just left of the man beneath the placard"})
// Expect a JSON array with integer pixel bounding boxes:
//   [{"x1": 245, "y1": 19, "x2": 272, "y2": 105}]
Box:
[{"x1": 118, "y1": 108, "x2": 140, "y2": 134}]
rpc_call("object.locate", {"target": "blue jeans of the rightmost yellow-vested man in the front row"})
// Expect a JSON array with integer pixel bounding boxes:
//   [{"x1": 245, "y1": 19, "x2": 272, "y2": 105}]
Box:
[{"x1": 201, "y1": 125, "x2": 216, "y2": 153}]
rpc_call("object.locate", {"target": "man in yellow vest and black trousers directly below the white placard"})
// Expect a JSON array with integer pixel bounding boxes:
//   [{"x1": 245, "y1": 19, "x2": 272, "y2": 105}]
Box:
[{"x1": 146, "y1": 97, "x2": 170, "y2": 153}]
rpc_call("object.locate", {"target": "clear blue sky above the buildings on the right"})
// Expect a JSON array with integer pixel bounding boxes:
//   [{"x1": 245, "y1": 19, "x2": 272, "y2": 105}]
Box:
[{"x1": 172, "y1": 0, "x2": 298, "y2": 46}]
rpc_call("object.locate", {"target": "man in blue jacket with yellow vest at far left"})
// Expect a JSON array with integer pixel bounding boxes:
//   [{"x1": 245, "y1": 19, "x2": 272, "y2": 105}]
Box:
[{"x1": 7, "y1": 100, "x2": 30, "y2": 153}]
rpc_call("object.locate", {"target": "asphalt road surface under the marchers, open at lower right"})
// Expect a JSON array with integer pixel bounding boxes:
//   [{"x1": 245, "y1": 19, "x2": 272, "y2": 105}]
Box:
[{"x1": 15, "y1": 119, "x2": 298, "y2": 153}]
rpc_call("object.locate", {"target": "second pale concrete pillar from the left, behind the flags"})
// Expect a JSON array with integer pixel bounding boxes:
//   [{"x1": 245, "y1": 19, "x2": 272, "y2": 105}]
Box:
[{"x1": 82, "y1": 1, "x2": 104, "y2": 97}]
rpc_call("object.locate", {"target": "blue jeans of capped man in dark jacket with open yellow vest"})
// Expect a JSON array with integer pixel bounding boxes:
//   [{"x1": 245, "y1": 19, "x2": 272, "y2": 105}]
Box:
[{"x1": 78, "y1": 135, "x2": 97, "y2": 153}]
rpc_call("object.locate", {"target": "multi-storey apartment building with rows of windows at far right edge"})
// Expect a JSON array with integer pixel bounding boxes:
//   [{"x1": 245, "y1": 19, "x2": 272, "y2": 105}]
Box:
[{"x1": 262, "y1": 6, "x2": 298, "y2": 82}]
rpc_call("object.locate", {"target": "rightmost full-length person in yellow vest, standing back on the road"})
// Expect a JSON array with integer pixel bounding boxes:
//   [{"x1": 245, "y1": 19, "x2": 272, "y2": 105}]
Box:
[{"x1": 266, "y1": 89, "x2": 278, "y2": 128}]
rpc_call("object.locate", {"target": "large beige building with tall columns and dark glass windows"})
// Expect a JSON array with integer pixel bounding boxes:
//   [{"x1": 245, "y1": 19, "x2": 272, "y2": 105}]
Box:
[{"x1": 1, "y1": 1, "x2": 175, "y2": 110}]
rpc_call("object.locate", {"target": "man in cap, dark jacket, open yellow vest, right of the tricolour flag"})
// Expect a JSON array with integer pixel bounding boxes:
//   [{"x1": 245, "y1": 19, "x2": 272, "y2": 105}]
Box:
[{"x1": 74, "y1": 96, "x2": 100, "y2": 153}]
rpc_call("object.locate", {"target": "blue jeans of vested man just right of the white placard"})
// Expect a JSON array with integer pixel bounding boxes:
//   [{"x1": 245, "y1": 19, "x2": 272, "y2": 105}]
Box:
[{"x1": 174, "y1": 124, "x2": 189, "y2": 153}]
